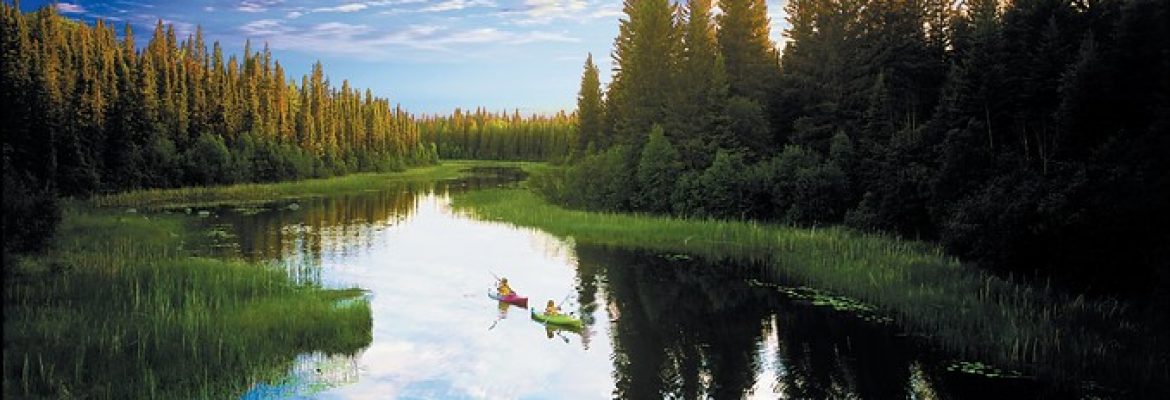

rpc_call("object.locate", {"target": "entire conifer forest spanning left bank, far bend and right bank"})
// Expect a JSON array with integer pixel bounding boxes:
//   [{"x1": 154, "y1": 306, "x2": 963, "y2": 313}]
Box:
[{"x1": 0, "y1": 0, "x2": 1170, "y2": 303}]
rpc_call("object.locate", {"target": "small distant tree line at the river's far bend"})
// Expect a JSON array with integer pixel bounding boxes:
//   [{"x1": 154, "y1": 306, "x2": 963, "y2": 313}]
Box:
[{"x1": 415, "y1": 108, "x2": 577, "y2": 161}]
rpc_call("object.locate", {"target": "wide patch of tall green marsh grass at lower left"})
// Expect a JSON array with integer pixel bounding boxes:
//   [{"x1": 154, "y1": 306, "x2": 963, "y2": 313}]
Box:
[{"x1": 4, "y1": 204, "x2": 372, "y2": 399}]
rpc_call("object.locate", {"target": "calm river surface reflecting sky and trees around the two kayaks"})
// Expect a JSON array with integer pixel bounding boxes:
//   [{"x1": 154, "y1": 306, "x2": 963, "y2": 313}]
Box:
[{"x1": 189, "y1": 174, "x2": 1062, "y2": 399}]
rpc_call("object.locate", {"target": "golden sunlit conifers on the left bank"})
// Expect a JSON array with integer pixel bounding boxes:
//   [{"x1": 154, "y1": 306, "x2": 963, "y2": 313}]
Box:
[{"x1": 0, "y1": 4, "x2": 436, "y2": 254}]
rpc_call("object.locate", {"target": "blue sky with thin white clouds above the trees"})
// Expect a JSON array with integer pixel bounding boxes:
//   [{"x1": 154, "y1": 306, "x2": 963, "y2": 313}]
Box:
[{"x1": 20, "y1": 0, "x2": 786, "y2": 113}]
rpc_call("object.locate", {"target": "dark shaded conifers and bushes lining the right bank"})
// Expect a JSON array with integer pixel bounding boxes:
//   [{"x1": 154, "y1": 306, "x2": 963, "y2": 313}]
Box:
[{"x1": 536, "y1": 0, "x2": 1170, "y2": 295}]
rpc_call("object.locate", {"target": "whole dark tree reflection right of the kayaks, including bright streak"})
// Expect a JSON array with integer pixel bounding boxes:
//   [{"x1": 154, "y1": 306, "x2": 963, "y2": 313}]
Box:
[{"x1": 577, "y1": 246, "x2": 959, "y2": 399}]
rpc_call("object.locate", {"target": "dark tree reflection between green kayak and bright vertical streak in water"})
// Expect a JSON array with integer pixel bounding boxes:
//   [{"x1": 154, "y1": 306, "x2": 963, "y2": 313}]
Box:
[{"x1": 578, "y1": 247, "x2": 768, "y2": 399}]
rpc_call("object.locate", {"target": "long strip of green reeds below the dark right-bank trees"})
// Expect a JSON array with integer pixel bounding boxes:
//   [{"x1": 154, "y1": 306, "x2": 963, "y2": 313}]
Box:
[{"x1": 454, "y1": 184, "x2": 1168, "y2": 393}]
